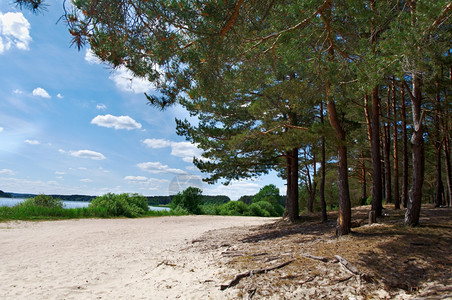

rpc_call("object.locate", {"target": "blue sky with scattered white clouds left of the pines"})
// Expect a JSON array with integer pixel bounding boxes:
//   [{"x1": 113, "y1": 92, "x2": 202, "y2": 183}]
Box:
[{"x1": 0, "y1": 0, "x2": 285, "y2": 200}]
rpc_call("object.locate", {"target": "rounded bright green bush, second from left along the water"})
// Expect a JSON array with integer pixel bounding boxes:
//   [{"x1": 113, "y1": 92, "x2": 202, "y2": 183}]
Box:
[{"x1": 89, "y1": 193, "x2": 149, "y2": 218}]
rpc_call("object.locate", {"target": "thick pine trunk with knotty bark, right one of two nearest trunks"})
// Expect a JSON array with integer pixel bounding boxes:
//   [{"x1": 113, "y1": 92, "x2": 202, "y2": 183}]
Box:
[{"x1": 405, "y1": 74, "x2": 424, "y2": 226}]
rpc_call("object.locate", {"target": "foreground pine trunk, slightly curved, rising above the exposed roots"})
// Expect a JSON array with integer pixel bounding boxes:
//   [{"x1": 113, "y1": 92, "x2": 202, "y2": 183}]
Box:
[{"x1": 327, "y1": 101, "x2": 352, "y2": 236}]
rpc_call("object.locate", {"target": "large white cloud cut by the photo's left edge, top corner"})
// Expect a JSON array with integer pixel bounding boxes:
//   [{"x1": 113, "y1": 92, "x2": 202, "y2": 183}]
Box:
[{"x1": 0, "y1": 12, "x2": 31, "y2": 54}]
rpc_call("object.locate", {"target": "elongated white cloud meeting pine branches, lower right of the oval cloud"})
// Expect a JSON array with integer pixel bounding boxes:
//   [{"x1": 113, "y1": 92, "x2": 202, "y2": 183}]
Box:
[{"x1": 143, "y1": 139, "x2": 202, "y2": 162}]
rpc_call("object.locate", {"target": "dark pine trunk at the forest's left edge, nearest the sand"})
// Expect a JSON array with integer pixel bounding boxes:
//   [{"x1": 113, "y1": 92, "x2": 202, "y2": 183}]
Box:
[{"x1": 285, "y1": 148, "x2": 299, "y2": 223}]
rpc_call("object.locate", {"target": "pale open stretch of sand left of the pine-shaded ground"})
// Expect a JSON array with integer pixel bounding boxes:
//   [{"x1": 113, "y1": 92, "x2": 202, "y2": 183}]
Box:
[{"x1": 0, "y1": 216, "x2": 273, "y2": 299}]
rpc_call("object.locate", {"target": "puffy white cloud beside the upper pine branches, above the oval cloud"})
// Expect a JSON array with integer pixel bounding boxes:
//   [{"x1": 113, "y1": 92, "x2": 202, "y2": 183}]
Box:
[{"x1": 109, "y1": 66, "x2": 156, "y2": 94}]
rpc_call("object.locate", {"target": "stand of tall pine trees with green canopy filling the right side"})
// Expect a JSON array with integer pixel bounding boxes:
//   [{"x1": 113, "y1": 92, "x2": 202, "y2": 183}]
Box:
[{"x1": 16, "y1": 0, "x2": 452, "y2": 235}]
